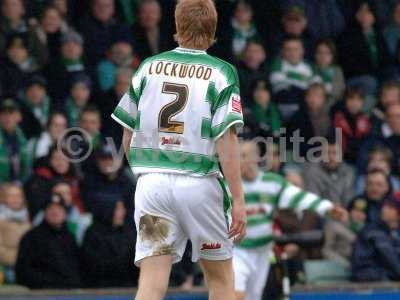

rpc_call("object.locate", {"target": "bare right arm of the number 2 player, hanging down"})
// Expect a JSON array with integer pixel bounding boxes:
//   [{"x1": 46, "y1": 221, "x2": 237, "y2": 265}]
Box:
[{"x1": 217, "y1": 127, "x2": 247, "y2": 240}]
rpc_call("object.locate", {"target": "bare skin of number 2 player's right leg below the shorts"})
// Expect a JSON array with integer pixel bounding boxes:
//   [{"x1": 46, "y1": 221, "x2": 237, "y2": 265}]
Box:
[{"x1": 200, "y1": 259, "x2": 235, "y2": 300}]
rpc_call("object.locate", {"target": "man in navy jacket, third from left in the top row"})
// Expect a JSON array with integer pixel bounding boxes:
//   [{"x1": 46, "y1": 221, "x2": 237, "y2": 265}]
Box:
[{"x1": 80, "y1": 0, "x2": 130, "y2": 67}]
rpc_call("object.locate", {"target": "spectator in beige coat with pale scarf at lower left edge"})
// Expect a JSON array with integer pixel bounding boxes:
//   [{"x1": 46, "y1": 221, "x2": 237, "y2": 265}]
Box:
[{"x1": 0, "y1": 183, "x2": 31, "y2": 279}]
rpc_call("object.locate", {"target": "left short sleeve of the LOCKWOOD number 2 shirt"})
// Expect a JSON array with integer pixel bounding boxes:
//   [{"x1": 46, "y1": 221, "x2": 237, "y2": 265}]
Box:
[{"x1": 111, "y1": 93, "x2": 137, "y2": 131}]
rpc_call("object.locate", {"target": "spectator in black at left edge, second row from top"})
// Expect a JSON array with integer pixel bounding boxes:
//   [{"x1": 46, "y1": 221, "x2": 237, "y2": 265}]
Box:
[{"x1": 0, "y1": 36, "x2": 39, "y2": 98}]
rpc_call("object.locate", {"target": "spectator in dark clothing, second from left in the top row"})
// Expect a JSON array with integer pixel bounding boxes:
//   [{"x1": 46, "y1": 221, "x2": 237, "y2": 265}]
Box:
[{"x1": 35, "y1": 6, "x2": 69, "y2": 65}]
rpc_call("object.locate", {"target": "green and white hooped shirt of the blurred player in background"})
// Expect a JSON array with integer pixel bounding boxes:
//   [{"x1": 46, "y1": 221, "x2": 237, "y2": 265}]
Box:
[{"x1": 239, "y1": 172, "x2": 333, "y2": 248}]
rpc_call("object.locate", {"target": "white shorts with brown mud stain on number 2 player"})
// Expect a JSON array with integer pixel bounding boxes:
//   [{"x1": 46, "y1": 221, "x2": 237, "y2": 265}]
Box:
[{"x1": 135, "y1": 173, "x2": 233, "y2": 266}]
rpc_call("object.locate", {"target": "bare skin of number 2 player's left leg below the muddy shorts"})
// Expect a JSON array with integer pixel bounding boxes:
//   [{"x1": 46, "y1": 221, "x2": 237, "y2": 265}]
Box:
[{"x1": 135, "y1": 255, "x2": 172, "y2": 300}]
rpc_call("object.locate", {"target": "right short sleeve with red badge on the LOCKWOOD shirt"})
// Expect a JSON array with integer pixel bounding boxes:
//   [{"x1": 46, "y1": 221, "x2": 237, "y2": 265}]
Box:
[{"x1": 211, "y1": 85, "x2": 243, "y2": 140}]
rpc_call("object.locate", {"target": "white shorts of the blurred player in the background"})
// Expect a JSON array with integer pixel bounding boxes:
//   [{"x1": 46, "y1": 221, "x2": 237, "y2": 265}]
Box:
[{"x1": 233, "y1": 246, "x2": 272, "y2": 300}]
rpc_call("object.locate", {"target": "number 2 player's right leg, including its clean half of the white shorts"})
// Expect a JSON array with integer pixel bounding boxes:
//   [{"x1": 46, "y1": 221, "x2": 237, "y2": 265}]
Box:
[{"x1": 174, "y1": 176, "x2": 235, "y2": 300}]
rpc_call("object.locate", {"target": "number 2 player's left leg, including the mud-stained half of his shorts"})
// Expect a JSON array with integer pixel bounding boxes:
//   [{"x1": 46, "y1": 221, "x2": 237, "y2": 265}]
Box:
[{"x1": 135, "y1": 174, "x2": 187, "y2": 300}]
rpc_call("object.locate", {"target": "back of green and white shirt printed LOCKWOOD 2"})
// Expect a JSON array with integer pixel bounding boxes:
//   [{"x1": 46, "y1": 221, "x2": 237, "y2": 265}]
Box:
[{"x1": 113, "y1": 48, "x2": 243, "y2": 176}]
